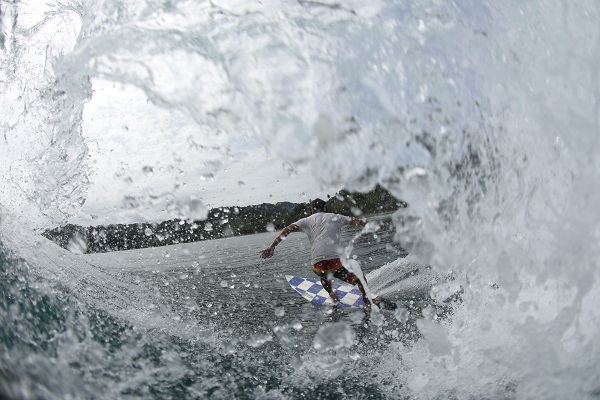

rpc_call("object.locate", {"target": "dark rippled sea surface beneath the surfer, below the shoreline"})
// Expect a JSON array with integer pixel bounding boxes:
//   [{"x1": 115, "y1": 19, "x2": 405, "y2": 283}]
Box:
[{"x1": 2, "y1": 218, "x2": 436, "y2": 398}]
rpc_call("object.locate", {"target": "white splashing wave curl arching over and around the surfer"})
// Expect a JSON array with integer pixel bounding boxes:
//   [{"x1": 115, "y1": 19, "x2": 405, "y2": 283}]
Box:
[{"x1": 0, "y1": 0, "x2": 600, "y2": 399}]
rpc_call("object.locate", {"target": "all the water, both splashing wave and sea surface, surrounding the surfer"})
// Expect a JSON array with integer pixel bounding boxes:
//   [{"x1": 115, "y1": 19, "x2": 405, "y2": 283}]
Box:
[{"x1": 0, "y1": 0, "x2": 600, "y2": 399}]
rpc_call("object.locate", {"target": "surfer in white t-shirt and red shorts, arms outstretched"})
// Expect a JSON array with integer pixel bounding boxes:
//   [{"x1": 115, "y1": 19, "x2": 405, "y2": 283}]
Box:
[{"x1": 260, "y1": 199, "x2": 381, "y2": 307}]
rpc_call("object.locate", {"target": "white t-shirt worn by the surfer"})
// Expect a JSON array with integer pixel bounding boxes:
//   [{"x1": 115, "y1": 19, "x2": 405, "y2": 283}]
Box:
[{"x1": 295, "y1": 213, "x2": 352, "y2": 265}]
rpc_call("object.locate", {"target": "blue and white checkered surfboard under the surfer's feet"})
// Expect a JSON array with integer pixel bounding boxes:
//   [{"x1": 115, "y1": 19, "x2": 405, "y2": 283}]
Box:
[{"x1": 285, "y1": 275, "x2": 365, "y2": 308}]
